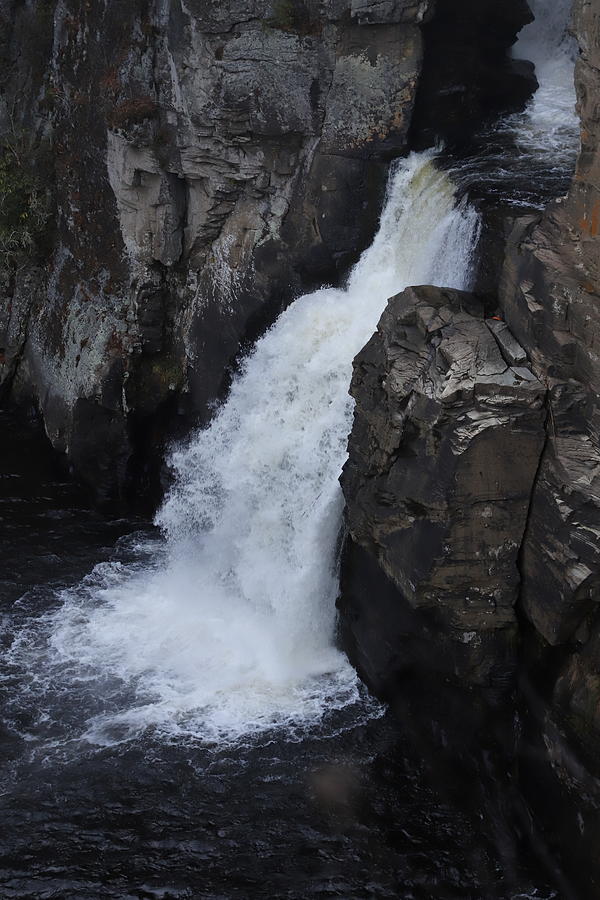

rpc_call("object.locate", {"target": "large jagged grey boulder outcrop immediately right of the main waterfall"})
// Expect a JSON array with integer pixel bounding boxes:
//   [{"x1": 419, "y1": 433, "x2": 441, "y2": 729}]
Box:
[{"x1": 341, "y1": 287, "x2": 546, "y2": 689}]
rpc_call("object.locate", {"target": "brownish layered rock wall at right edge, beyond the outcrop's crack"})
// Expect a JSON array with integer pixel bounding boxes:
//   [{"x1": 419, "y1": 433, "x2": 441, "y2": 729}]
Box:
[{"x1": 500, "y1": 0, "x2": 600, "y2": 755}]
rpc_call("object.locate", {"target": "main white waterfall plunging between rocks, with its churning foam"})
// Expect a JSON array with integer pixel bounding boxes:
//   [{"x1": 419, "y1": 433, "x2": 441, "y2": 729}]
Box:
[{"x1": 4, "y1": 153, "x2": 479, "y2": 745}]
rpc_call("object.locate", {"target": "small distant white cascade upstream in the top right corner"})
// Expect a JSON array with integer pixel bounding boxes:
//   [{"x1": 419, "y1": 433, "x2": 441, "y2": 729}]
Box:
[{"x1": 512, "y1": 0, "x2": 579, "y2": 160}]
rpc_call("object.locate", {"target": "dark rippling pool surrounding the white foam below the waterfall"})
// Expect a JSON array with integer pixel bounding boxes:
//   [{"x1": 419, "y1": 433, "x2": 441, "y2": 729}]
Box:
[{"x1": 0, "y1": 414, "x2": 572, "y2": 900}]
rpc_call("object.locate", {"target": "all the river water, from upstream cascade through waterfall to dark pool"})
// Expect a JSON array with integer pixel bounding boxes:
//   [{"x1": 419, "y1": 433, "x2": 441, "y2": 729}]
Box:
[{"x1": 0, "y1": 0, "x2": 576, "y2": 900}]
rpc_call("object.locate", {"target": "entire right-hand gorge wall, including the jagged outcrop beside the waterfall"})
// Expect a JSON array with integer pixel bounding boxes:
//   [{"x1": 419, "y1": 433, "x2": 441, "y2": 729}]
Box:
[{"x1": 340, "y1": 0, "x2": 600, "y2": 884}]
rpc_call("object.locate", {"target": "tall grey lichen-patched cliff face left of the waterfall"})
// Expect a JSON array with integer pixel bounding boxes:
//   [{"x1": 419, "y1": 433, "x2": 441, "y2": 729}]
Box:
[{"x1": 0, "y1": 0, "x2": 430, "y2": 499}]
